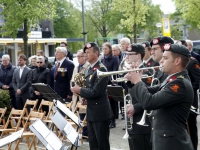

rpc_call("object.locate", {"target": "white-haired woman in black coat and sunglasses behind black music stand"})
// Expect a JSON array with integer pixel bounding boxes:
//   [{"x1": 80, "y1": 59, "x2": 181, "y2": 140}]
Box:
[{"x1": 32, "y1": 56, "x2": 51, "y2": 114}]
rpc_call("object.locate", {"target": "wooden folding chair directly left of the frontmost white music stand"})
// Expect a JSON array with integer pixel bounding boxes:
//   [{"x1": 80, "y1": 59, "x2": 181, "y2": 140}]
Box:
[{"x1": 15, "y1": 111, "x2": 45, "y2": 150}]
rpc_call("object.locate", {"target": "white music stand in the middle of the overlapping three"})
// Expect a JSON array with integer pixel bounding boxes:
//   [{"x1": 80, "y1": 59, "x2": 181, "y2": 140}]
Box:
[{"x1": 51, "y1": 111, "x2": 82, "y2": 147}]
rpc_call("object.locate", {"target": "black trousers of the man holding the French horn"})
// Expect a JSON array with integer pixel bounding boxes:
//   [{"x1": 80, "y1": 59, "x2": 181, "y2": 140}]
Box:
[{"x1": 87, "y1": 120, "x2": 110, "y2": 150}]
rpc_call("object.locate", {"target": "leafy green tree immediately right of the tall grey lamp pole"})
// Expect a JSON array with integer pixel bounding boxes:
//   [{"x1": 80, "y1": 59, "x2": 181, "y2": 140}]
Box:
[{"x1": 86, "y1": 0, "x2": 121, "y2": 37}]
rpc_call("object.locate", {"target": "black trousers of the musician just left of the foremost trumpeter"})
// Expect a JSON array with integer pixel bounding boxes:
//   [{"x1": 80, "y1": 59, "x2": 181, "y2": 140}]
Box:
[{"x1": 128, "y1": 134, "x2": 152, "y2": 150}]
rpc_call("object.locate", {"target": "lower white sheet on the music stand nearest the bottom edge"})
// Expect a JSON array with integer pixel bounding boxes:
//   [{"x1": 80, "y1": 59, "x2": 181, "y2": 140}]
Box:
[{"x1": 46, "y1": 132, "x2": 62, "y2": 150}]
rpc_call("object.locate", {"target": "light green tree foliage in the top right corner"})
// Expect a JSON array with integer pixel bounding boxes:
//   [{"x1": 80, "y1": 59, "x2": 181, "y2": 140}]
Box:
[{"x1": 173, "y1": 0, "x2": 200, "y2": 28}]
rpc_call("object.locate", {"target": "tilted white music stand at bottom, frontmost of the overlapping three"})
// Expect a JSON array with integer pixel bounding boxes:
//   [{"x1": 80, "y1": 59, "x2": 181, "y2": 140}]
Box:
[{"x1": 29, "y1": 119, "x2": 68, "y2": 150}]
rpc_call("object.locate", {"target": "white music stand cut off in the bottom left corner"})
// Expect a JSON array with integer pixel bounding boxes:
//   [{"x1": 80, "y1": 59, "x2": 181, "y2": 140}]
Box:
[{"x1": 0, "y1": 129, "x2": 24, "y2": 148}]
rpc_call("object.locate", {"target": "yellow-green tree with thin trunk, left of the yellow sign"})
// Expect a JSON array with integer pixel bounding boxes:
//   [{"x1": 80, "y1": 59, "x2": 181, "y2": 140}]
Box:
[{"x1": 112, "y1": 0, "x2": 148, "y2": 43}]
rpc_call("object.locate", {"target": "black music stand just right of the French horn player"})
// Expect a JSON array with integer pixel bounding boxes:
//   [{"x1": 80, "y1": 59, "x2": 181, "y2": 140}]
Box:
[{"x1": 107, "y1": 85, "x2": 124, "y2": 102}]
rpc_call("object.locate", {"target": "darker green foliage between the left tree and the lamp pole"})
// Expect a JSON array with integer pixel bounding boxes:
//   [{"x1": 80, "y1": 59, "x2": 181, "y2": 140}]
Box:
[{"x1": 54, "y1": 0, "x2": 83, "y2": 52}]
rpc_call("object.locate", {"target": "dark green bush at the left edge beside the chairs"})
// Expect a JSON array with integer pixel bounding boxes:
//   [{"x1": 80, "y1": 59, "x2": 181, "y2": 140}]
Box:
[{"x1": 0, "y1": 89, "x2": 11, "y2": 117}]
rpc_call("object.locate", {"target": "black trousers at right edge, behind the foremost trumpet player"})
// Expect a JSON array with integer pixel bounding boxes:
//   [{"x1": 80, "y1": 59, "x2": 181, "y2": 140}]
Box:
[{"x1": 188, "y1": 113, "x2": 198, "y2": 150}]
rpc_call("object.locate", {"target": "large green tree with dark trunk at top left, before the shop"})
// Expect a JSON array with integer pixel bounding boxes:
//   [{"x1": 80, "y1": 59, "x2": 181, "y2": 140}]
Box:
[{"x1": 0, "y1": 0, "x2": 55, "y2": 56}]
